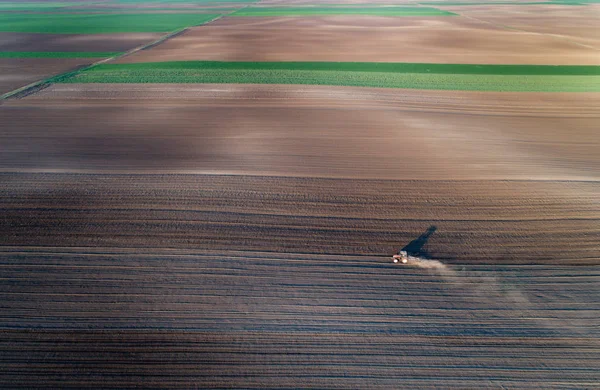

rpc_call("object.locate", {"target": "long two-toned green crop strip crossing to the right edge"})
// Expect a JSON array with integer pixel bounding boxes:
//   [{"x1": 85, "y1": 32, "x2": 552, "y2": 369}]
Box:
[{"x1": 52, "y1": 61, "x2": 600, "y2": 92}]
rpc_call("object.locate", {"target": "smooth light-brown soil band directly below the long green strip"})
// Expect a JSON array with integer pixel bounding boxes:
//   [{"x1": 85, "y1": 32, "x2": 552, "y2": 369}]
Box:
[{"x1": 5, "y1": 84, "x2": 600, "y2": 180}]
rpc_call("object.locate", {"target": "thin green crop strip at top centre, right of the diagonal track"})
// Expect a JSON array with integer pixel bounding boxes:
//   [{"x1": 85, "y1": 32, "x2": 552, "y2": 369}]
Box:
[{"x1": 232, "y1": 6, "x2": 455, "y2": 16}]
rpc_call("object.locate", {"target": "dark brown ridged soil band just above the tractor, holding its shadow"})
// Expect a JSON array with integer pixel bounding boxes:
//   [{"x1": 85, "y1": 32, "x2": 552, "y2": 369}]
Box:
[{"x1": 0, "y1": 172, "x2": 600, "y2": 266}]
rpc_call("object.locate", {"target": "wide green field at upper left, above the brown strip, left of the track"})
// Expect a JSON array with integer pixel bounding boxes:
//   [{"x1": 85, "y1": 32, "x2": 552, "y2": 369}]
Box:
[{"x1": 0, "y1": 13, "x2": 220, "y2": 34}]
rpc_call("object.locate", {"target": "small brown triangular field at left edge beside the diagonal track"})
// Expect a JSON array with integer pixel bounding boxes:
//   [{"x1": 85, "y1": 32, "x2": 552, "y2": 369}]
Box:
[{"x1": 0, "y1": 58, "x2": 86, "y2": 94}]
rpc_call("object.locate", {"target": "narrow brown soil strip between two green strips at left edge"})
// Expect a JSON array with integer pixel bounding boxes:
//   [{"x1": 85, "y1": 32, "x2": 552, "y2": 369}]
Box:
[{"x1": 0, "y1": 32, "x2": 164, "y2": 51}]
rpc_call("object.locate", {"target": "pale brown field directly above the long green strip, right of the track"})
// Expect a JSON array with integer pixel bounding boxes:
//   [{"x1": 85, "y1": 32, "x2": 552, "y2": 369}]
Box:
[{"x1": 119, "y1": 16, "x2": 600, "y2": 65}]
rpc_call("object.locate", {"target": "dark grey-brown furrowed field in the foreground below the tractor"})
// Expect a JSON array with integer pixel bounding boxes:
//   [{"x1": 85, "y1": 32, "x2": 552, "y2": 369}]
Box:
[{"x1": 0, "y1": 247, "x2": 600, "y2": 389}]
